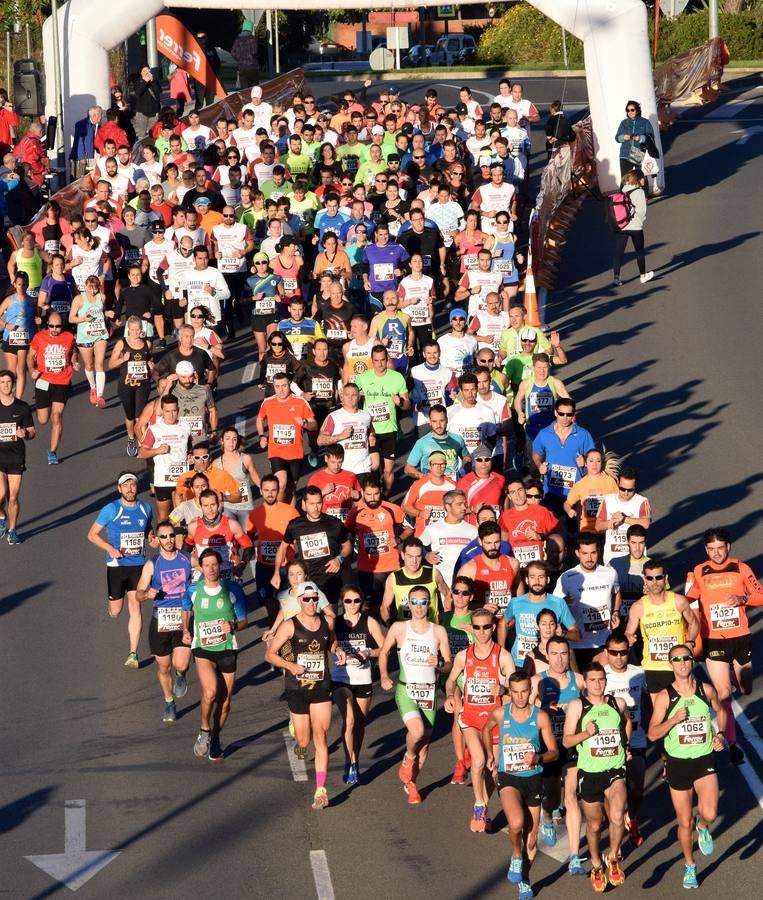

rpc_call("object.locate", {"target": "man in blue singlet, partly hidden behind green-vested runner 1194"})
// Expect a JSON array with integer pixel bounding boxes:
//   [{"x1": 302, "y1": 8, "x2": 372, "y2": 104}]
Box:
[{"x1": 533, "y1": 632, "x2": 585, "y2": 875}]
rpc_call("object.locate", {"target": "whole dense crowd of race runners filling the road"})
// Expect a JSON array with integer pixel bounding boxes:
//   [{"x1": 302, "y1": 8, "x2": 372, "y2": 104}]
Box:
[{"x1": 0, "y1": 80, "x2": 763, "y2": 900}]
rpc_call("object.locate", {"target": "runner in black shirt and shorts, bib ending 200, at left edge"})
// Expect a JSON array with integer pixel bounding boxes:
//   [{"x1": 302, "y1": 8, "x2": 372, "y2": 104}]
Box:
[{"x1": 0, "y1": 369, "x2": 35, "y2": 547}]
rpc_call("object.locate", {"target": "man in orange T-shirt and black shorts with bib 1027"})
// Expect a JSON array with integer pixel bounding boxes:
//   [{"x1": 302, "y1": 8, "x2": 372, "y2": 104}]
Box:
[{"x1": 686, "y1": 528, "x2": 763, "y2": 766}]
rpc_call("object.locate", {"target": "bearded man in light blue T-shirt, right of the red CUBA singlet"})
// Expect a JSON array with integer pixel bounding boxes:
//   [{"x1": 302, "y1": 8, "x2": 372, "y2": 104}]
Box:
[{"x1": 498, "y1": 560, "x2": 581, "y2": 668}]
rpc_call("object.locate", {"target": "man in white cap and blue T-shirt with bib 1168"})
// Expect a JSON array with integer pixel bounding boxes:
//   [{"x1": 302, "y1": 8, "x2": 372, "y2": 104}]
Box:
[{"x1": 88, "y1": 472, "x2": 153, "y2": 669}]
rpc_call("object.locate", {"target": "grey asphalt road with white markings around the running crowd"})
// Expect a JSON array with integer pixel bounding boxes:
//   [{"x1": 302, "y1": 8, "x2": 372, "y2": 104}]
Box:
[{"x1": 0, "y1": 74, "x2": 763, "y2": 900}]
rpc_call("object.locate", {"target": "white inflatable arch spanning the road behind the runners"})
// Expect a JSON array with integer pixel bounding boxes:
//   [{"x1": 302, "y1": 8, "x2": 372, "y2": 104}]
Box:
[{"x1": 43, "y1": 0, "x2": 662, "y2": 191}]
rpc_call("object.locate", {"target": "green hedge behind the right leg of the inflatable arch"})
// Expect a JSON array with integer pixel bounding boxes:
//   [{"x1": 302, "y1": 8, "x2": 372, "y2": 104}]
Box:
[{"x1": 477, "y1": 3, "x2": 763, "y2": 69}]
